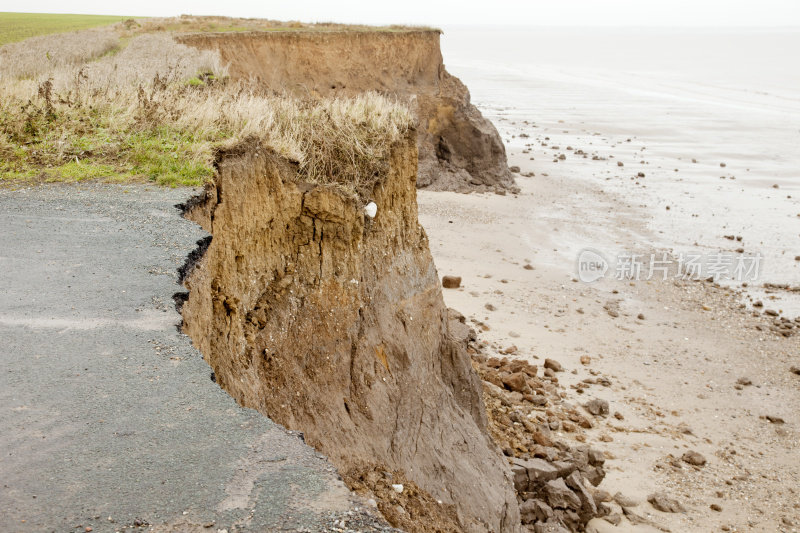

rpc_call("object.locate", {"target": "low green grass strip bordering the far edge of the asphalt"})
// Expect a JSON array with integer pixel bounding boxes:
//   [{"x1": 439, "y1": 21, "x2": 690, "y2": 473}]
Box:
[{"x1": 0, "y1": 102, "x2": 220, "y2": 187}]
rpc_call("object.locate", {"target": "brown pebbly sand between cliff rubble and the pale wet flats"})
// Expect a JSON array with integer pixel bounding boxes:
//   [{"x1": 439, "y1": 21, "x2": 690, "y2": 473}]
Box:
[{"x1": 418, "y1": 143, "x2": 800, "y2": 531}]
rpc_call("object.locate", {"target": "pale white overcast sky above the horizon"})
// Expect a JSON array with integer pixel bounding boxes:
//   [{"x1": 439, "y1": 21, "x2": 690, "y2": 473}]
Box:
[{"x1": 6, "y1": 0, "x2": 800, "y2": 26}]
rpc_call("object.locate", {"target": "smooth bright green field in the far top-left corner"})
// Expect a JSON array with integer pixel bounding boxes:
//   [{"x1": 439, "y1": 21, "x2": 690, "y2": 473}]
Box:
[{"x1": 0, "y1": 12, "x2": 128, "y2": 46}]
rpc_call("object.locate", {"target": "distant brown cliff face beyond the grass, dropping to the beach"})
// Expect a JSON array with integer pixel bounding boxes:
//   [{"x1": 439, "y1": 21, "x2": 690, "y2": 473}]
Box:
[{"x1": 176, "y1": 31, "x2": 516, "y2": 192}]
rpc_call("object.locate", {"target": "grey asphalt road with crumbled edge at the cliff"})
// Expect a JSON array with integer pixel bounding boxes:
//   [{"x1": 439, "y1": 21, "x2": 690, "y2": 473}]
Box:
[{"x1": 0, "y1": 185, "x2": 394, "y2": 532}]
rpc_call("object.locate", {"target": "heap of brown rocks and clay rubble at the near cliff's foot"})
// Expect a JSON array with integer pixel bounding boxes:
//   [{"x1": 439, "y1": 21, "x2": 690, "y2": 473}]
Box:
[{"x1": 470, "y1": 348, "x2": 611, "y2": 532}]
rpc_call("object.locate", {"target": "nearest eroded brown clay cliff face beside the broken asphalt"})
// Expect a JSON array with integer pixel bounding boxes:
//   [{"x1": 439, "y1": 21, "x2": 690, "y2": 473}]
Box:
[{"x1": 183, "y1": 133, "x2": 520, "y2": 531}]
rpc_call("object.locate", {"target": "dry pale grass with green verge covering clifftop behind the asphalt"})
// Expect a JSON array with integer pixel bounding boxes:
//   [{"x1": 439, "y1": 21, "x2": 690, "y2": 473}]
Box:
[{"x1": 0, "y1": 25, "x2": 413, "y2": 196}]
